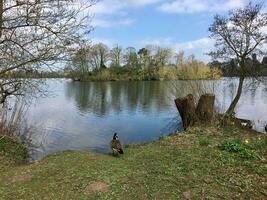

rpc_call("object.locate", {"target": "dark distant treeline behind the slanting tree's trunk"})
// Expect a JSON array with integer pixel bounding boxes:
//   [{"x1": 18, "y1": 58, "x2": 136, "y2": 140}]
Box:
[{"x1": 208, "y1": 54, "x2": 267, "y2": 77}]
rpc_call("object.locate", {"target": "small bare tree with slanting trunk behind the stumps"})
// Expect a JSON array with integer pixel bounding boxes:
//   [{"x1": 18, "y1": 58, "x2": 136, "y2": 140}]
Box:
[{"x1": 209, "y1": 3, "x2": 267, "y2": 115}]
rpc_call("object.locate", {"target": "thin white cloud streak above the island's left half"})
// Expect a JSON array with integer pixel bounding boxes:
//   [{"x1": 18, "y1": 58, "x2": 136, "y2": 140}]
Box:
[{"x1": 92, "y1": 18, "x2": 135, "y2": 28}]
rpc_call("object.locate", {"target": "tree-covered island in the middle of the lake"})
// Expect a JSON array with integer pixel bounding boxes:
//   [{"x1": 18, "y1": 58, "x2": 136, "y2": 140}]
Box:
[{"x1": 64, "y1": 43, "x2": 221, "y2": 81}]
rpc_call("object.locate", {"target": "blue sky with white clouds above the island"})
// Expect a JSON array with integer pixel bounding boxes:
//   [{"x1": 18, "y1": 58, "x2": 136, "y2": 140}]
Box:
[{"x1": 90, "y1": 0, "x2": 264, "y2": 62}]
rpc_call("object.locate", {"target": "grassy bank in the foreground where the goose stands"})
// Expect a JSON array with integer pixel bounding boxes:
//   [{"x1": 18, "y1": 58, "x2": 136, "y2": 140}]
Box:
[{"x1": 0, "y1": 126, "x2": 267, "y2": 199}]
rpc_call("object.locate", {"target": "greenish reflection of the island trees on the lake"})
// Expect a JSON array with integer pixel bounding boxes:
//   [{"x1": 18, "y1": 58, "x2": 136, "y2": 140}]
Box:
[{"x1": 65, "y1": 82, "x2": 173, "y2": 117}]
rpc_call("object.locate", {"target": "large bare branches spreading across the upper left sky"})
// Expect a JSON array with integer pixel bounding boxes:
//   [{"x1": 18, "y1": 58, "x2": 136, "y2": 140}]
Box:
[{"x1": 0, "y1": 0, "x2": 97, "y2": 103}]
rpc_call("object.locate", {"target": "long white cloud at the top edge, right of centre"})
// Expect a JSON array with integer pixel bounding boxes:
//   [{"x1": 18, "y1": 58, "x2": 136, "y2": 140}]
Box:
[{"x1": 158, "y1": 0, "x2": 245, "y2": 13}]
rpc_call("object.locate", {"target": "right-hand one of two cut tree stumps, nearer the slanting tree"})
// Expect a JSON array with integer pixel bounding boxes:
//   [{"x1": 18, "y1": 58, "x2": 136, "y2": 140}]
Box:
[{"x1": 196, "y1": 94, "x2": 215, "y2": 122}]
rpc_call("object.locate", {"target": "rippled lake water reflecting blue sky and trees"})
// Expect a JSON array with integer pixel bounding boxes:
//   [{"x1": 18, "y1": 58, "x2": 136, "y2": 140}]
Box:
[{"x1": 27, "y1": 78, "x2": 267, "y2": 160}]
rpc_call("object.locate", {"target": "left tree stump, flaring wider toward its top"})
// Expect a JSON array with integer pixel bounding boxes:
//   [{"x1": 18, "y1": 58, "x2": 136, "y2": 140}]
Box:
[{"x1": 174, "y1": 94, "x2": 196, "y2": 130}]
